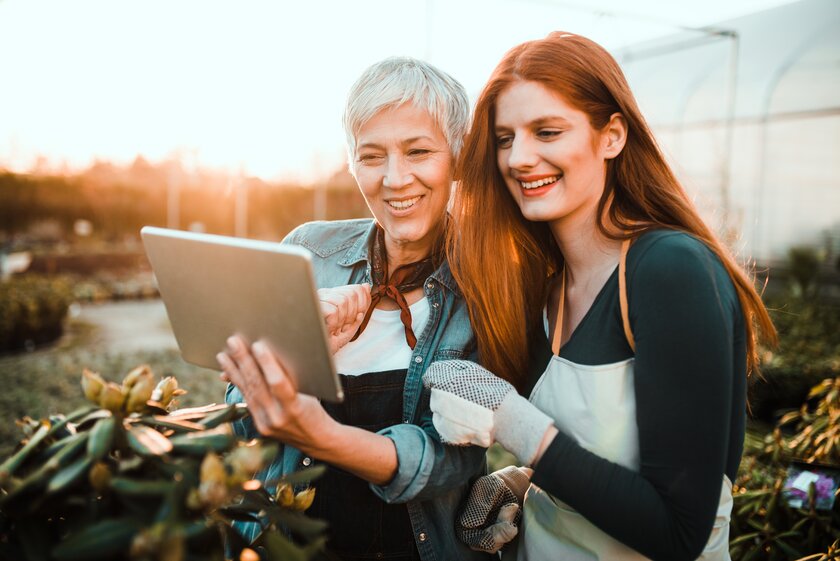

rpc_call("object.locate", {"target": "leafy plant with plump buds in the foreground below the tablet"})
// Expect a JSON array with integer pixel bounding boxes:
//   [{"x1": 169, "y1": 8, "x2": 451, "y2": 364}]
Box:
[{"x1": 0, "y1": 366, "x2": 326, "y2": 561}]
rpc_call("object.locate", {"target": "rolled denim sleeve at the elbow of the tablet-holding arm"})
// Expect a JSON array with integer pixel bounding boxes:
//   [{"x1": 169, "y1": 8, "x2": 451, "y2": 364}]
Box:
[{"x1": 370, "y1": 418, "x2": 487, "y2": 503}]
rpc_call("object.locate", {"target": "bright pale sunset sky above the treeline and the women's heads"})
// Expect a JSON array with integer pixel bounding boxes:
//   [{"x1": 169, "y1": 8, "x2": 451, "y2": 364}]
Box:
[{"x1": 0, "y1": 0, "x2": 787, "y2": 183}]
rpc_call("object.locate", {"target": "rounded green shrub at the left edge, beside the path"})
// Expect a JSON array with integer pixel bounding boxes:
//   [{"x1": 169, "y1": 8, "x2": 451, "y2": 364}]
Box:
[{"x1": 0, "y1": 275, "x2": 73, "y2": 351}]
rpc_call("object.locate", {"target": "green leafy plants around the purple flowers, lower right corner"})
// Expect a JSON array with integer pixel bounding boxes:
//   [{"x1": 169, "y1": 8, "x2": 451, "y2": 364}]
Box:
[{"x1": 730, "y1": 377, "x2": 840, "y2": 561}]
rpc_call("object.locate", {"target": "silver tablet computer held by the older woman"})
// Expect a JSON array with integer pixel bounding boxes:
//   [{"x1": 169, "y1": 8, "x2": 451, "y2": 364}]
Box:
[{"x1": 140, "y1": 226, "x2": 343, "y2": 401}]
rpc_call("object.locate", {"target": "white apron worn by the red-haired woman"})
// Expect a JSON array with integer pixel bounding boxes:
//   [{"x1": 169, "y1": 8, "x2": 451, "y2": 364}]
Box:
[{"x1": 503, "y1": 355, "x2": 732, "y2": 561}]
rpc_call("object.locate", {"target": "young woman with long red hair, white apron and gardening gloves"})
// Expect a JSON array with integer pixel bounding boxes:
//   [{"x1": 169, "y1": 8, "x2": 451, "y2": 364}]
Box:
[{"x1": 425, "y1": 32, "x2": 776, "y2": 560}]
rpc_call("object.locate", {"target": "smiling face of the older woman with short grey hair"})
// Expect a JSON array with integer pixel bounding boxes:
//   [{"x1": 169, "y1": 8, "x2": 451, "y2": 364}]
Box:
[{"x1": 353, "y1": 103, "x2": 453, "y2": 258}]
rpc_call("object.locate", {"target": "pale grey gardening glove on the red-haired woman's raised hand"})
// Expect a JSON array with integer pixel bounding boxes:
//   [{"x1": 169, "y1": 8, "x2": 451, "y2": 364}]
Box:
[{"x1": 423, "y1": 360, "x2": 552, "y2": 466}]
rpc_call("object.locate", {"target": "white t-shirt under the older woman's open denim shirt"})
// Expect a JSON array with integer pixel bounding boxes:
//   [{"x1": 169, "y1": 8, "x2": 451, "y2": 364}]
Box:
[{"x1": 333, "y1": 296, "x2": 429, "y2": 376}]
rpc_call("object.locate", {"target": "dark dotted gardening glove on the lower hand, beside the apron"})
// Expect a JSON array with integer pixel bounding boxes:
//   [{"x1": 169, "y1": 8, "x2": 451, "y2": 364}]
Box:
[{"x1": 455, "y1": 466, "x2": 531, "y2": 553}]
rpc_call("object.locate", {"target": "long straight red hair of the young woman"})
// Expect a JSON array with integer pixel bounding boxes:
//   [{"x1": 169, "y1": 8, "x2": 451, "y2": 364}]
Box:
[{"x1": 447, "y1": 32, "x2": 776, "y2": 388}]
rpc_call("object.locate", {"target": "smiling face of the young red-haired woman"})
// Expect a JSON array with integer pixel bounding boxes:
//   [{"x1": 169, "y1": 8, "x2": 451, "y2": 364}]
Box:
[{"x1": 495, "y1": 81, "x2": 614, "y2": 229}]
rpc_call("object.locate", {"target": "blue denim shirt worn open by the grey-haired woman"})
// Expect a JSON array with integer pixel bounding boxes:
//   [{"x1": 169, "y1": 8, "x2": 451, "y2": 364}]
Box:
[{"x1": 225, "y1": 219, "x2": 491, "y2": 561}]
